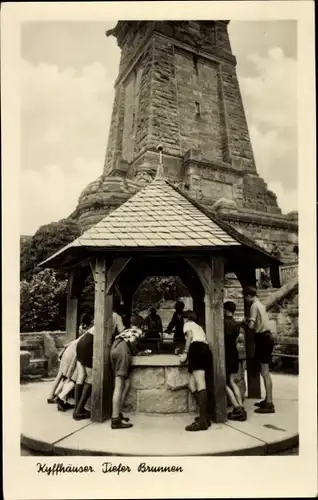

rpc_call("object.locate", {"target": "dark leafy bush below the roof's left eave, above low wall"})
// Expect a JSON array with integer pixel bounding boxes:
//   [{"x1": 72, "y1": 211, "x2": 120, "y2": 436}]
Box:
[{"x1": 20, "y1": 269, "x2": 67, "y2": 332}]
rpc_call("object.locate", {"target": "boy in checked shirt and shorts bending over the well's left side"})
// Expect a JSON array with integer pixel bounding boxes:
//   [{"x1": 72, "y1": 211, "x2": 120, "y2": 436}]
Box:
[{"x1": 110, "y1": 315, "x2": 143, "y2": 429}]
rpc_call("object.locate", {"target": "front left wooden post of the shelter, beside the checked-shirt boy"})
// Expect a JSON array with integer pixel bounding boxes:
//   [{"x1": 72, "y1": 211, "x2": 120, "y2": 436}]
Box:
[{"x1": 91, "y1": 255, "x2": 113, "y2": 422}]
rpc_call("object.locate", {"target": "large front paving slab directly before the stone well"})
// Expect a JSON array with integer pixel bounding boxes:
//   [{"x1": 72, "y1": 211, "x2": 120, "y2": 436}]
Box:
[{"x1": 54, "y1": 414, "x2": 264, "y2": 456}]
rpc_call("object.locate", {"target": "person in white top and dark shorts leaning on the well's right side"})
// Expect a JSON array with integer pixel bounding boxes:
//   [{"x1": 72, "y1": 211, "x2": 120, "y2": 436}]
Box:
[{"x1": 180, "y1": 311, "x2": 212, "y2": 431}]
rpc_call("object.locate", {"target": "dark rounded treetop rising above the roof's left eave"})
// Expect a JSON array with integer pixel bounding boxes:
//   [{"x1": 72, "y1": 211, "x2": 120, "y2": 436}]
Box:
[{"x1": 20, "y1": 219, "x2": 81, "y2": 280}]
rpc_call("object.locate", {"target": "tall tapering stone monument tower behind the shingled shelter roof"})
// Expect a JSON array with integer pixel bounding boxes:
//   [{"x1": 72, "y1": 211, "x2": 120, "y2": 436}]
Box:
[{"x1": 73, "y1": 21, "x2": 298, "y2": 262}]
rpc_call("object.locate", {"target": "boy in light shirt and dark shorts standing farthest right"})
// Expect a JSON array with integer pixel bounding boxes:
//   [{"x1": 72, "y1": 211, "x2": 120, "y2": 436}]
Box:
[{"x1": 243, "y1": 286, "x2": 275, "y2": 413}]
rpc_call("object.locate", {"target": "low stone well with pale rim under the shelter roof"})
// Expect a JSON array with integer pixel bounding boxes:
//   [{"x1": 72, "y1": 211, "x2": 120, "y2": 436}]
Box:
[{"x1": 121, "y1": 354, "x2": 196, "y2": 413}]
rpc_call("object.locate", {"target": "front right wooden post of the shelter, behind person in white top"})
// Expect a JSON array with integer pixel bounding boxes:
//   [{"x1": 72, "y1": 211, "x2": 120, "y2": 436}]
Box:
[{"x1": 205, "y1": 255, "x2": 227, "y2": 422}]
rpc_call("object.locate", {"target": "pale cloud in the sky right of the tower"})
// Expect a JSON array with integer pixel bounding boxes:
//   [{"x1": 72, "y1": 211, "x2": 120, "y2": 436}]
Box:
[{"x1": 240, "y1": 47, "x2": 297, "y2": 212}]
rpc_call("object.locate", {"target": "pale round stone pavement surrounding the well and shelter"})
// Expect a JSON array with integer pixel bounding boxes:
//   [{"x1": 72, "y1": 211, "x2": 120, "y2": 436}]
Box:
[{"x1": 21, "y1": 374, "x2": 298, "y2": 456}]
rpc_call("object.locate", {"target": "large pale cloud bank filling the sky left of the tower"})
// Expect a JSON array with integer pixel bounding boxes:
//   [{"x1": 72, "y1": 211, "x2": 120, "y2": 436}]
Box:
[{"x1": 21, "y1": 61, "x2": 113, "y2": 234}]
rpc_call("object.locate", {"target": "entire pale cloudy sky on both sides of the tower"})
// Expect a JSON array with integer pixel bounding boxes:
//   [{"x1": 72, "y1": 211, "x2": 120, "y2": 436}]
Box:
[{"x1": 20, "y1": 21, "x2": 297, "y2": 235}]
